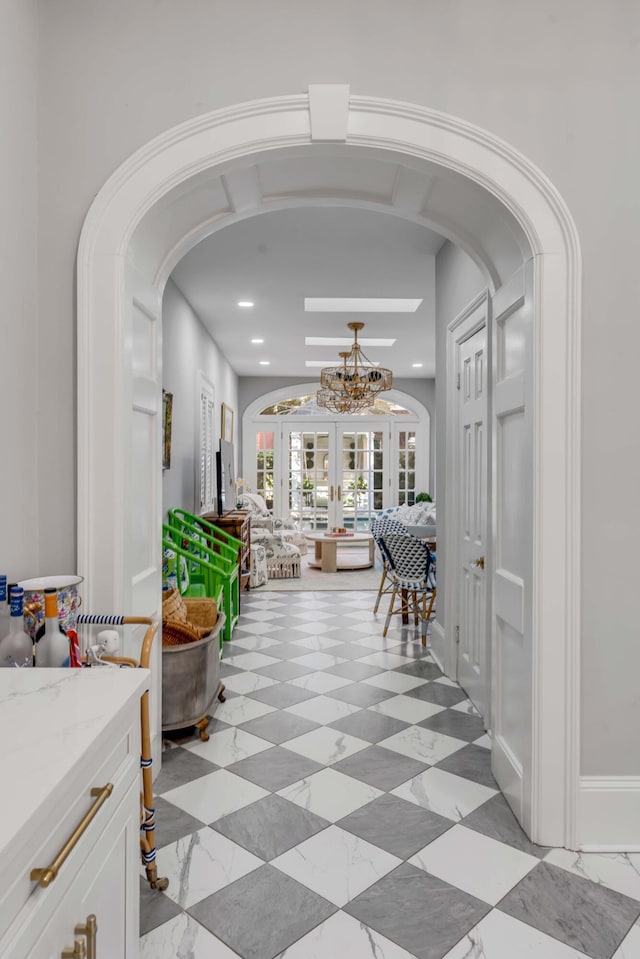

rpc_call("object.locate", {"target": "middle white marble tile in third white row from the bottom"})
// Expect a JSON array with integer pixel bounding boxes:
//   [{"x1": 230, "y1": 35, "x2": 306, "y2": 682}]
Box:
[{"x1": 278, "y1": 769, "x2": 382, "y2": 822}]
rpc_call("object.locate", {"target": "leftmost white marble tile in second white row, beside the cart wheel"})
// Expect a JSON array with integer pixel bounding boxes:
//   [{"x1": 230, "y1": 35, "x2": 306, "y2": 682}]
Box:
[{"x1": 157, "y1": 828, "x2": 264, "y2": 909}]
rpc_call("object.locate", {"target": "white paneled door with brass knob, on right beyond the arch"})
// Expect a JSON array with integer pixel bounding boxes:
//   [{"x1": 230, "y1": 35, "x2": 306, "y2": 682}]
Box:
[{"x1": 457, "y1": 323, "x2": 488, "y2": 717}]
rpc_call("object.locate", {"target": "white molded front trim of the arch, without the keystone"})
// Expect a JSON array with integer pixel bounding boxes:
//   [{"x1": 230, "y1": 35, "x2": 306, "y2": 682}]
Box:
[{"x1": 78, "y1": 95, "x2": 581, "y2": 847}]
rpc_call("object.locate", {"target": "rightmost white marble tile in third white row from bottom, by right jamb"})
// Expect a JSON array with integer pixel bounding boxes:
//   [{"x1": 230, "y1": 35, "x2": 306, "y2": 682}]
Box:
[{"x1": 390, "y1": 768, "x2": 497, "y2": 822}]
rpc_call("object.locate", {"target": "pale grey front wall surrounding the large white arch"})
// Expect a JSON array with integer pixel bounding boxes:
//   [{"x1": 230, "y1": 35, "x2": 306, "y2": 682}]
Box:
[{"x1": 28, "y1": 0, "x2": 640, "y2": 775}]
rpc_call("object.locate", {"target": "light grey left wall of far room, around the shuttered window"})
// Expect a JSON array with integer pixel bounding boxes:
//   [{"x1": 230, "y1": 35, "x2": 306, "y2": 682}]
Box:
[{"x1": 162, "y1": 280, "x2": 238, "y2": 514}]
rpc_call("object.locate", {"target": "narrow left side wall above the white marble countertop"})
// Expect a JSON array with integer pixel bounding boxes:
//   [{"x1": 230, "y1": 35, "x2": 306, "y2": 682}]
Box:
[{"x1": 0, "y1": 0, "x2": 38, "y2": 581}]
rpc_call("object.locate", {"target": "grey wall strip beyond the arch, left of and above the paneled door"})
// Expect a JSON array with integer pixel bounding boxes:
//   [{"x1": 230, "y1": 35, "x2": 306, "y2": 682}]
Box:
[{"x1": 435, "y1": 242, "x2": 487, "y2": 626}]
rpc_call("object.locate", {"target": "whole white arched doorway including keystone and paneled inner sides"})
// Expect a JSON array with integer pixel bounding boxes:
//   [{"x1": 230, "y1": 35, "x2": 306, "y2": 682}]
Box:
[{"x1": 78, "y1": 87, "x2": 580, "y2": 846}]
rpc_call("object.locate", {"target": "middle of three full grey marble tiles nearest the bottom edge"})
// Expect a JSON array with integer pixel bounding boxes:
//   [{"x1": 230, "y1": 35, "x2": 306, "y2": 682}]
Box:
[{"x1": 344, "y1": 863, "x2": 490, "y2": 959}]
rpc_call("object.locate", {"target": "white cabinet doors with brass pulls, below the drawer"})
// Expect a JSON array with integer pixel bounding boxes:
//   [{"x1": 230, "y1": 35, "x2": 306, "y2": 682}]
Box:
[{"x1": 18, "y1": 779, "x2": 140, "y2": 959}]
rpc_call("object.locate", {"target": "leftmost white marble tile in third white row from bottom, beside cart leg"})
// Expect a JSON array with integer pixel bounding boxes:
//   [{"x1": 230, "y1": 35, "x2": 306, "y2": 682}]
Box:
[{"x1": 162, "y1": 769, "x2": 269, "y2": 824}]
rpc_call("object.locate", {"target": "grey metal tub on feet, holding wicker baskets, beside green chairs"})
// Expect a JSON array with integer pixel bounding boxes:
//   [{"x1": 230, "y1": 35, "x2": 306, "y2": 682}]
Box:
[{"x1": 162, "y1": 613, "x2": 225, "y2": 730}]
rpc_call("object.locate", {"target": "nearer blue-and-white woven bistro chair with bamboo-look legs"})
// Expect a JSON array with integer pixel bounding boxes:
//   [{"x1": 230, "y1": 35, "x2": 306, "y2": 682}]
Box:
[{"x1": 381, "y1": 533, "x2": 436, "y2": 646}]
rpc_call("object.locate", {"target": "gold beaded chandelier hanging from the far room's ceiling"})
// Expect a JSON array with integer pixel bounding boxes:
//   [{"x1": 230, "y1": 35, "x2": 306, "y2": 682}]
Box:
[{"x1": 317, "y1": 323, "x2": 393, "y2": 413}]
